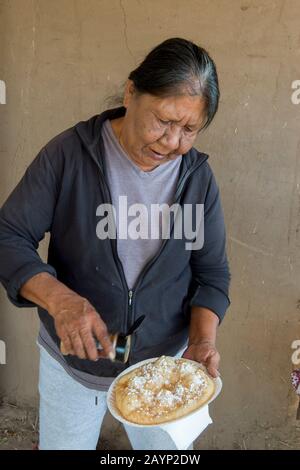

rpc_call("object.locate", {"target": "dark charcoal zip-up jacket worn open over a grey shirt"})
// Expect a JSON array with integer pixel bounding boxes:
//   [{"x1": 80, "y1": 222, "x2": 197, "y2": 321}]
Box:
[{"x1": 0, "y1": 107, "x2": 230, "y2": 377}]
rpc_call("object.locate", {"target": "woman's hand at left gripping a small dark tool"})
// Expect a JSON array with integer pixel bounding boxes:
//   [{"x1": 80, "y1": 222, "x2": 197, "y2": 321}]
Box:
[{"x1": 48, "y1": 291, "x2": 115, "y2": 361}]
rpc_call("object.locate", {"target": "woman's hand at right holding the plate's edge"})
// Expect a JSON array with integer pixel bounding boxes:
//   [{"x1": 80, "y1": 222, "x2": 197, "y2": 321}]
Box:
[{"x1": 182, "y1": 340, "x2": 220, "y2": 378}]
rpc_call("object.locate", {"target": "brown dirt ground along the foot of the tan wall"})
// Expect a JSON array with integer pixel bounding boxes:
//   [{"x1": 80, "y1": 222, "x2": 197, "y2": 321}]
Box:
[{"x1": 0, "y1": 402, "x2": 300, "y2": 450}]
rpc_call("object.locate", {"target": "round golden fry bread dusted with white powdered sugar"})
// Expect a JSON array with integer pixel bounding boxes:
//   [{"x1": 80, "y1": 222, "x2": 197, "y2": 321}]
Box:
[{"x1": 115, "y1": 356, "x2": 215, "y2": 424}]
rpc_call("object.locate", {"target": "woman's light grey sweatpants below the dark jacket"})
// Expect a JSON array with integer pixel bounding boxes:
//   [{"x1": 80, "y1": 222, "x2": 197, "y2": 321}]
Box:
[{"x1": 39, "y1": 346, "x2": 193, "y2": 450}]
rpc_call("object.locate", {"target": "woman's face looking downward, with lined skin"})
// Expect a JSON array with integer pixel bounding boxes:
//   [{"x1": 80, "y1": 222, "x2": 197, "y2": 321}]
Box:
[{"x1": 112, "y1": 80, "x2": 206, "y2": 171}]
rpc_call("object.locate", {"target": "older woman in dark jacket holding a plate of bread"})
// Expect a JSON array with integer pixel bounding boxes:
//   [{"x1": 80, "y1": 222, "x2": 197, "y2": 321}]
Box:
[{"x1": 0, "y1": 38, "x2": 230, "y2": 449}]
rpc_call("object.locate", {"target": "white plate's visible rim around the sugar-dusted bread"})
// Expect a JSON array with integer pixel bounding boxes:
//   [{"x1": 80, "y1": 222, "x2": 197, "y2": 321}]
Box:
[{"x1": 107, "y1": 357, "x2": 222, "y2": 428}]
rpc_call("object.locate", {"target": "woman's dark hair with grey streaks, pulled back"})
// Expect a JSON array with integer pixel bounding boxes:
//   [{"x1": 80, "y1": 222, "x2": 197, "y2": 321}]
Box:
[{"x1": 128, "y1": 38, "x2": 220, "y2": 129}]
